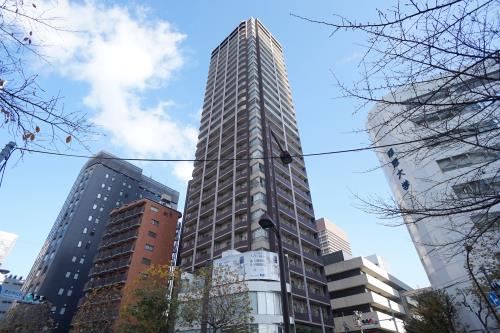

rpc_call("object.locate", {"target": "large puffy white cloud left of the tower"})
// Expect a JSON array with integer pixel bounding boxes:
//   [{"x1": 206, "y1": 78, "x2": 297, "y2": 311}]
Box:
[{"x1": 22, "y1": 0, "x2": 197, "y2": 180}]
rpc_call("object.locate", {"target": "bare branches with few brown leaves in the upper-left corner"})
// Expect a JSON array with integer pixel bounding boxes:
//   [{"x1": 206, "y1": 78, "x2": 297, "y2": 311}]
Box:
[{"x1": 0, "y1": 0, "x2": 92, "y2": 149}]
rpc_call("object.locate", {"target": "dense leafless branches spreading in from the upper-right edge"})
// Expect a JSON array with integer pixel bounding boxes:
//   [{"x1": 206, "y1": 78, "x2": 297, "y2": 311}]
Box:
[{"x1": 295, "y1": 0, "x2": 500, "y2": 256}]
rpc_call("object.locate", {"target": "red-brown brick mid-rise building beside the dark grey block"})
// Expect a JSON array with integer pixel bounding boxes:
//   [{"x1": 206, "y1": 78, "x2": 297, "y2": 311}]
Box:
[{"x1": 73, "y1": 199, "x2": 181, "y2": 324}]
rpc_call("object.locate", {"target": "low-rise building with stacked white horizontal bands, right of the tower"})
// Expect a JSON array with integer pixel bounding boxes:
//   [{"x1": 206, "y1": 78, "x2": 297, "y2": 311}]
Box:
[{"x1": 323, "y1": 251, "x2": 411, "y2": 333}]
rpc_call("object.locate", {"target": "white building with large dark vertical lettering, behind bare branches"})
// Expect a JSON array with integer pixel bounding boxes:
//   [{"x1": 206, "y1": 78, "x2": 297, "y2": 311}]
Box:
[{"x1": 367, "y1": 65, "x2": 500, "y2": 331}]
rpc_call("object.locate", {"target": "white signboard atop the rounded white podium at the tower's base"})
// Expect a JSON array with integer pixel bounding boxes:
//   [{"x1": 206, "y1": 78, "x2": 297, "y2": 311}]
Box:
[{"x1": 214, "y1": 251, "x2": 280, "y2": 281}]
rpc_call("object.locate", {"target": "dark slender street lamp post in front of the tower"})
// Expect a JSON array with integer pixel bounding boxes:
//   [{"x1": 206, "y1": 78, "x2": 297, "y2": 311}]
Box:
[{"x1": 259, "y1": 127, "x2": 293, "y2": 333}]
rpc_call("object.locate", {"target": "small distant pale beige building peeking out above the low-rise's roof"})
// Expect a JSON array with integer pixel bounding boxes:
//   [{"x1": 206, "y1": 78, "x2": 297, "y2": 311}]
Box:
[{"x1": 316, "y1": 217, "x2": 352, "y2": 255}]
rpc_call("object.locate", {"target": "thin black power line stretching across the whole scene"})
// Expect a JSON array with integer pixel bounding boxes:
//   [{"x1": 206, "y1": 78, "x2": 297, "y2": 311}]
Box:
[{"x1": 14, "y1": 128, "x2": 498, "y2": 162}]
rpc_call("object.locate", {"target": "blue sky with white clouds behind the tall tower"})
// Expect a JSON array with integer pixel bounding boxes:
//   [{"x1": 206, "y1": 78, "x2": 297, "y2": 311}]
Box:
[{"x1": 0, "y1": 0, "x2": 428, "y2": 287}]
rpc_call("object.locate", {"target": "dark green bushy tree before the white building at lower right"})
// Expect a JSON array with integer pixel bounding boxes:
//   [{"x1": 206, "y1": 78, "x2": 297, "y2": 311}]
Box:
[{"x1": 405, "y1": 290, "x2": 465, "y2": 333}]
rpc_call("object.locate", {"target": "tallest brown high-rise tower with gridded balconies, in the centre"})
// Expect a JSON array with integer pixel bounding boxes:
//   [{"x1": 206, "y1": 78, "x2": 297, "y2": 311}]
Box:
[{"x1": 180, "y1": 18, "x2": 332, "y2": 328}]
